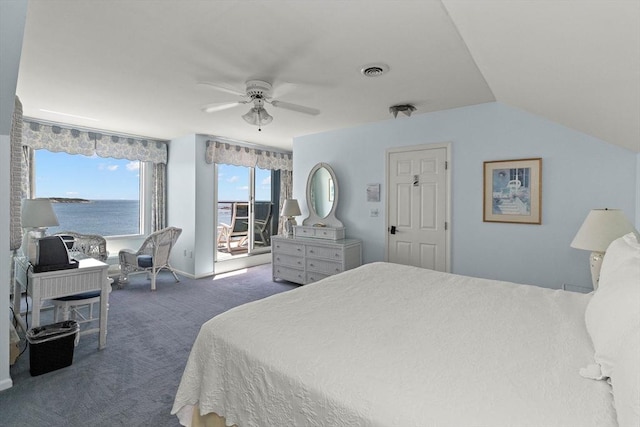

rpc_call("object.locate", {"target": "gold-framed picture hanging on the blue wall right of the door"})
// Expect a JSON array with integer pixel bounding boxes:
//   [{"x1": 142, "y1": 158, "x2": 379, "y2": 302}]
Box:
[{"x1": 482, "y1": 158, "x2": 542, "y2": 224}]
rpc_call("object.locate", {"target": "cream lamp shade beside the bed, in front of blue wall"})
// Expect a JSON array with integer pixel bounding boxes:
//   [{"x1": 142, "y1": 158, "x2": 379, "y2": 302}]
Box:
[{"x1": 571, "y1": 209, "x2": 635, "y2": 252}]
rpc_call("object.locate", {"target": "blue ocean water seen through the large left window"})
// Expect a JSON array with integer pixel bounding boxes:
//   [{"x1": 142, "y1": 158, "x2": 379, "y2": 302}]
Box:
[{"x1": 47, "y1": 200, "x2": 140, "y2": 236}]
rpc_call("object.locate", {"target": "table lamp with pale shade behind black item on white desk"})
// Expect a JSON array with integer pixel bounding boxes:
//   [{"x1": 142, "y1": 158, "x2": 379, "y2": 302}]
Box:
[{"x1": 20, "y1": 199, "x2": 60, "y2": 265}]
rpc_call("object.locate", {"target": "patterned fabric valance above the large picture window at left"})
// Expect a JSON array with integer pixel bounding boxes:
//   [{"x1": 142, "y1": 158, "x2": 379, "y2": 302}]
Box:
[{"x1": 22, "y1": 121, "x2": 167, "y2": 164}]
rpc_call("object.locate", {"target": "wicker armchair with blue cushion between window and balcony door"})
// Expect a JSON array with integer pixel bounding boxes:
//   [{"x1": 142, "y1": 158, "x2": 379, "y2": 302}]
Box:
[{"x1": 118, "y1": 227, "x2": 182, "y2": 291}]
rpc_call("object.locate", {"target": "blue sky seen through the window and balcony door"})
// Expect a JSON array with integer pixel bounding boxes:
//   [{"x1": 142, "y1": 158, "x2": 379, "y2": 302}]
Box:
[{"x1": 35, "y1": 150, "x2": 271, "y2": 201}]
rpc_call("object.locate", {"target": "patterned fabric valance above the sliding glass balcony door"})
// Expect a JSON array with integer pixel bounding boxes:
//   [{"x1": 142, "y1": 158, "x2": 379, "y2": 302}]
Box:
[{"x1": 205, "y1": 141, "x2": 293, "y2": 171}]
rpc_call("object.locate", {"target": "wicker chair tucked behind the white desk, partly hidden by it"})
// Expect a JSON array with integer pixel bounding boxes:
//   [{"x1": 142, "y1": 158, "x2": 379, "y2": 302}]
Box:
[{"x1": 51, "y1": 231, "x2": 113, "y2": 335}]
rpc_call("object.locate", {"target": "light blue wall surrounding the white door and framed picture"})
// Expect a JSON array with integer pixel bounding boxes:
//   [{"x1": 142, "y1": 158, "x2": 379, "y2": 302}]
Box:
[{"x1": 293, "y1": 103, "x2": 639, "y2": 288}]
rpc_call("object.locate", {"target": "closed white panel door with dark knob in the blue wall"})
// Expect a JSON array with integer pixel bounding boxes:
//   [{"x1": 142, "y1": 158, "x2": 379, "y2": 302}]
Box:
[{"x1": 387, "y1": 146, "x2": 449, "y2": 271}]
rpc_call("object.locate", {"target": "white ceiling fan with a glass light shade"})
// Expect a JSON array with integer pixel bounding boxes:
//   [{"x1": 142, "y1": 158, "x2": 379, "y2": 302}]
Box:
[{"x1": 200, "y1": 80, "x2": 320, "y2": 131}]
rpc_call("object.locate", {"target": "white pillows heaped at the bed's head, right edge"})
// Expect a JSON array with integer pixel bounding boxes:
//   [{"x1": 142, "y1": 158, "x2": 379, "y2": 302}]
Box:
[{"x1": 585, "y1": 233, "x2": 640, "y2": 427}]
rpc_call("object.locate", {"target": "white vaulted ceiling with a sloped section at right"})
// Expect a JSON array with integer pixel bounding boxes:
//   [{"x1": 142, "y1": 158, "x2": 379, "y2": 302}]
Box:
[{"x1": 17, "y1": 0, "x2": 640, "y2": 152}]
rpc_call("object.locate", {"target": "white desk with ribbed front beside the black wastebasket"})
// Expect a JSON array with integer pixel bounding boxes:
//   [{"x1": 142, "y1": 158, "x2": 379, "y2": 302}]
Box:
[{"x1": 13, "y1": 257, "x2": 111, "y2": 349}]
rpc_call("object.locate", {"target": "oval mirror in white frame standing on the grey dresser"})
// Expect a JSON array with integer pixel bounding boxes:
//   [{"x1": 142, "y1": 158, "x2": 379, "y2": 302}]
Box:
[{"x1": 303, "y1": 163, "x2": 342, "y2": 227}]
